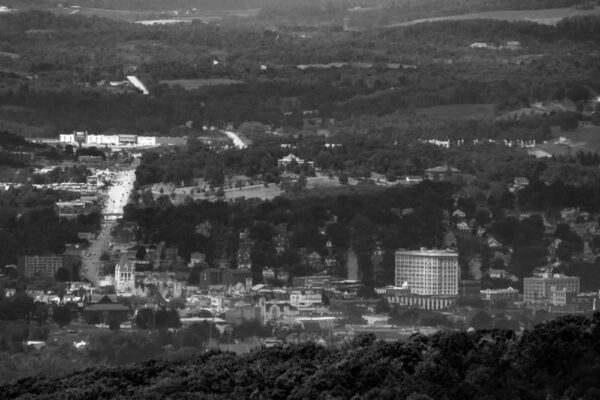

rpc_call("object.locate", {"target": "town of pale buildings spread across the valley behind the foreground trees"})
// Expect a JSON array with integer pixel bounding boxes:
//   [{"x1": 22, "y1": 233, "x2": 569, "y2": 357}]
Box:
[{"x1": 2, "y1": 125, "x2": 600, "y2": 366}]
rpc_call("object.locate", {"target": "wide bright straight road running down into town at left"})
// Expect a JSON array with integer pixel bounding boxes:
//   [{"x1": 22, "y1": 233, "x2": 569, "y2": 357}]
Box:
[{"x1": 81, "y1": 169, "x2": 135, "y2": 284}]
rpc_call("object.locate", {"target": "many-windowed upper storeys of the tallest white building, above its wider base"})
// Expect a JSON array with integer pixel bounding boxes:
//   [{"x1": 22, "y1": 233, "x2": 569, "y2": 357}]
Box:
[{"x1": 396, "y1": 248, "x2": 460, "y2": 296}]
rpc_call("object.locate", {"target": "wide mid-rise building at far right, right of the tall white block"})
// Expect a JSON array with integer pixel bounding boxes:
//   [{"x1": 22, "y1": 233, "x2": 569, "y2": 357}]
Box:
[{"x1": 523, "y1": 273, "x2": 579, "y2": 304}]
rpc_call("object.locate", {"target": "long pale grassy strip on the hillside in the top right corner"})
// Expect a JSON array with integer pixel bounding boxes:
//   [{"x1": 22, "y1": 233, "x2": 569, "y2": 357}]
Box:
[{"x1": 388, "y1": 8, "x2": 600, "y2": 27}]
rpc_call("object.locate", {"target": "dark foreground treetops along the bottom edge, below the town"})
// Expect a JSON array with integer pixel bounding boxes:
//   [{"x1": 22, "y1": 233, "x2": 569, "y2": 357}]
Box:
[{"x1": 0, "y1": 314, "x2": 600, "y2": 400}]
